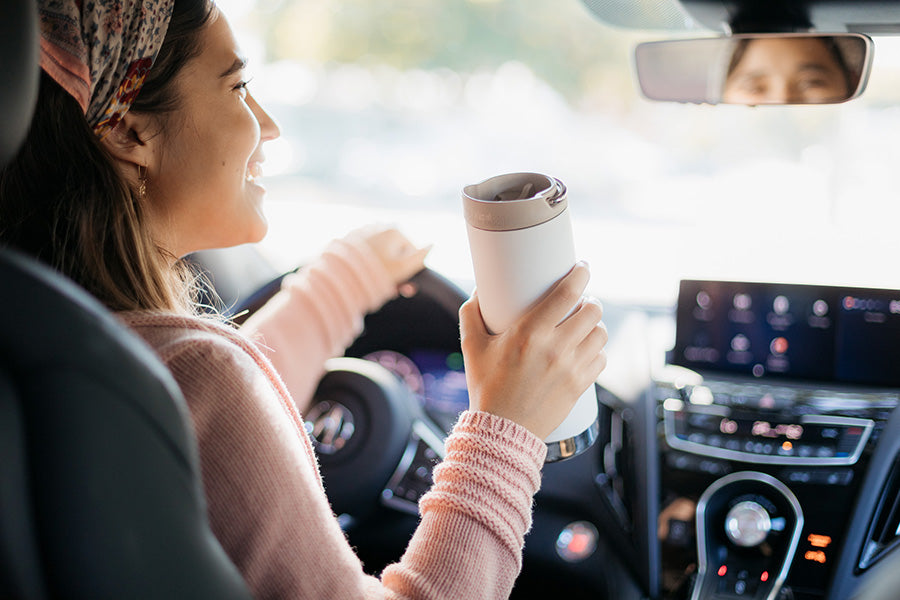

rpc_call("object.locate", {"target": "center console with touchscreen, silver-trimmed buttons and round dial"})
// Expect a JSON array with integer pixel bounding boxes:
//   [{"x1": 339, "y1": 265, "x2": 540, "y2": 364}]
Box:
[{"x1": 653, "y1": 280, "x2": 900, "y2": 600}]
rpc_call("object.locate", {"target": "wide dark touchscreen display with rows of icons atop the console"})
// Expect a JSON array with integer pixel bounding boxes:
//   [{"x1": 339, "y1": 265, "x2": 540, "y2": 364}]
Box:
[{"x1": 673, "y1": 280, "x2": 900, "y2": 386}]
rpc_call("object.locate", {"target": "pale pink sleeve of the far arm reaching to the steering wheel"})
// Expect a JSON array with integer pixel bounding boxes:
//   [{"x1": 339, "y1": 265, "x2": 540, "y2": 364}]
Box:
[{"x1": 241, "y1": 234, "x2": 397, "y2": 410}]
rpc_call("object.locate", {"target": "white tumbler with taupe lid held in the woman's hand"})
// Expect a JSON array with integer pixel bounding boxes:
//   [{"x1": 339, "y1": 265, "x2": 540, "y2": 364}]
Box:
[{"x1": 462, "y1": 173, "x2": 599, "y2": 462}]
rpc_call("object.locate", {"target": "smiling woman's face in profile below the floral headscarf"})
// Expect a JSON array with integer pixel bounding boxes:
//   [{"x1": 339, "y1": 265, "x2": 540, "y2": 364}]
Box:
[{"x1": 147, "y1": 9, "x2": 279, "y2": 257}]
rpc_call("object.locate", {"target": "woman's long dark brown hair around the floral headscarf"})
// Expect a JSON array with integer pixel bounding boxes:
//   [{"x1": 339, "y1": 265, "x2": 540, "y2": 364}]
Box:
[{"x1": 0, "y1": 0, "x2": 213, "y2": 312}]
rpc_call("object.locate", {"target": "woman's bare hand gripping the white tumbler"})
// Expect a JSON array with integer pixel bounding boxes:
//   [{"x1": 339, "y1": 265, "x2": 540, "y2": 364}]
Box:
[{"x1": 459, "y1": 263, "x2": 608, "y2": 439}]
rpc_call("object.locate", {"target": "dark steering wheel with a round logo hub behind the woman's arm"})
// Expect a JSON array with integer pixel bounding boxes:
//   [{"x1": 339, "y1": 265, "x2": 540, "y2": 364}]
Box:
[{"x1": 232, "y1": 269, "x2": 467, "y2": 529}]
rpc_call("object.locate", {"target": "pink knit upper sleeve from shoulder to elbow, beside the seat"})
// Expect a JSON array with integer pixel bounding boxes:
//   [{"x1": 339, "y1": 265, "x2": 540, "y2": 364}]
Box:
[{"x1": 153, "y1": 330, "x2": 369, "y2": 600}]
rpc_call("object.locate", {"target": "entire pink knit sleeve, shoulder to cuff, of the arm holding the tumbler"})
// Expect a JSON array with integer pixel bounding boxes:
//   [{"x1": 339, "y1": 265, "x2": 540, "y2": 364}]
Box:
[{"x1": 128, "y1": 317, "x2": 546, "y2": 600}]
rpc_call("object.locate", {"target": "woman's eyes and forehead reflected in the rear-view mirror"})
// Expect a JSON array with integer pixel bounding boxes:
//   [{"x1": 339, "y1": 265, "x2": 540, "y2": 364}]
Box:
[{"x1": 722, "y1": 37, "x2": 853, "y2": 104}]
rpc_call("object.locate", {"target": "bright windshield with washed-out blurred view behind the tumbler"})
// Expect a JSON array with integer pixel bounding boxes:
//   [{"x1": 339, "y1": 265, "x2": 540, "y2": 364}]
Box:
[{"x1": 219, "y1": 0, "x2": 900, "y2": 306}]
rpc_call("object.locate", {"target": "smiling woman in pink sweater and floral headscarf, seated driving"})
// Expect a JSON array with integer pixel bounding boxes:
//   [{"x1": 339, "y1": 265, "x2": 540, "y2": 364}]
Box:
[{"x1": 0, "y1": 0, "x2": 606, "y2": 598}]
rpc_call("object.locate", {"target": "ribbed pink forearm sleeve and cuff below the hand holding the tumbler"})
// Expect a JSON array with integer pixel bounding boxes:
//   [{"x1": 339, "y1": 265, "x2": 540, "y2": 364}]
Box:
[{"x1": 382, "y1": 411, "x2": 547, "y2": 600}]
